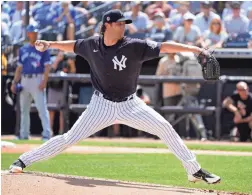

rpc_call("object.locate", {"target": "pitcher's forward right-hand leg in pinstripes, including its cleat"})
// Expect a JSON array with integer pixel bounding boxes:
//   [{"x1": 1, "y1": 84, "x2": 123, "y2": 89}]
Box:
[{"x1": 119, "y1": 98, "x2": 220, "y2": 183}]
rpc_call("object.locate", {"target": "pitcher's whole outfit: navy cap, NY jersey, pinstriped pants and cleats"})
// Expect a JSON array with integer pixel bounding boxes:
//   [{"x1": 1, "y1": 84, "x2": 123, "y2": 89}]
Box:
[{"x1": 10, "y1": 10, "x2": 220, "y2": 183}]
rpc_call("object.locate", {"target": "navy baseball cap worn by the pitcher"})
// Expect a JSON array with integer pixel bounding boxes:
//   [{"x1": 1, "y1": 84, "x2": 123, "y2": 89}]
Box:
[{"x1": 102, "y1": 9, "x2": 132, "y2": 24}]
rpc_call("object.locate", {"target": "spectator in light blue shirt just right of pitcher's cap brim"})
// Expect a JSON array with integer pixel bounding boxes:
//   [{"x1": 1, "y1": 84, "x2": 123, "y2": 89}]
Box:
[{"x1": 124, "y1": 2, "x2": 150, "y2": 39}]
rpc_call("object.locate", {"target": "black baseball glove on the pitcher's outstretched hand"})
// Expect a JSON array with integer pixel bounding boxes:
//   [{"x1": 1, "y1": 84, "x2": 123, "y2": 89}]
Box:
[{"x1": 197, "y1": 50, "x2": 220, "y2": 80}]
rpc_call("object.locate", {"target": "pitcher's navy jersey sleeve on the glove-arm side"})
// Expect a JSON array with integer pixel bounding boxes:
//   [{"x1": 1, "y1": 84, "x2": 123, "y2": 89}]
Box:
[{"x1": 134, "y1": 39, "x2": 161, "y2": 62}]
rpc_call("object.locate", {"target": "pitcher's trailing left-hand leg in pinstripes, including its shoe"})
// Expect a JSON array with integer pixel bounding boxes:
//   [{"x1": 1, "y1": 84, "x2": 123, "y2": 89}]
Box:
[{"x1": 10, "y1": 96, "x2": 115, "y2": 172}]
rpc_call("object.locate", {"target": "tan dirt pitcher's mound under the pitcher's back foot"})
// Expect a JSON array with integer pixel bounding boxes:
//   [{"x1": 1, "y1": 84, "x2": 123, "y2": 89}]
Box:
[{"x1": 1, "y1": 171, "x2": 215, "y2": 195}]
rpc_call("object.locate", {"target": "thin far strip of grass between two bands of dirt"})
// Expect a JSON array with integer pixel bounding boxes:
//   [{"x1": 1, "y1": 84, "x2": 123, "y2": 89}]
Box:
[{"x1": 4, "y1": 140, "x2": 252, "y2": 152}]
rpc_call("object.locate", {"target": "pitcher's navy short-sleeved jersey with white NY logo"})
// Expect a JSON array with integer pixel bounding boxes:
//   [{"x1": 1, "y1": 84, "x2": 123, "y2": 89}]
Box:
[{"x1": 74, "y1": 36, "x2": 161, "y2": 98}]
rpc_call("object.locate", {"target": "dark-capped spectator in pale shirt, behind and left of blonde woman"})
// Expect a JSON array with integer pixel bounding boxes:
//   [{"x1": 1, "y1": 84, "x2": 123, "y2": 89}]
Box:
[{"x1": 193, "y1": 1, "x2": 220, "y2": 33}]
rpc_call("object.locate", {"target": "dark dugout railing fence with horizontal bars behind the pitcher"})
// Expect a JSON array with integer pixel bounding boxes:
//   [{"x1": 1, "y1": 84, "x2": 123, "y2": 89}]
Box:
[{"x1": 8, "y1": 74, "x2": 252, "y2": 140}]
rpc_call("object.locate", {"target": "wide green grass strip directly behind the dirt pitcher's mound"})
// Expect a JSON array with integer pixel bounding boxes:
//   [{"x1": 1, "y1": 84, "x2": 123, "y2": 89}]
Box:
[{"x1": 1, "y1": 154, "x2": 252, "y2": 193}]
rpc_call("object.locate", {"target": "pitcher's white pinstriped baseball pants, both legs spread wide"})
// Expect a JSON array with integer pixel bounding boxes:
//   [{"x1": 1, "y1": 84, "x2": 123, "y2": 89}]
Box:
[{"x1": 19, "y1": 94, "x2": 200, "y2": 174}]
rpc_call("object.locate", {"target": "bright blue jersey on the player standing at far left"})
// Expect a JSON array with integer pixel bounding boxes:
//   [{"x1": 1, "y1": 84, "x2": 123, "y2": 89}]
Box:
[{"x1": 18, "y1": 44, "x2": 51, "y2": 74}]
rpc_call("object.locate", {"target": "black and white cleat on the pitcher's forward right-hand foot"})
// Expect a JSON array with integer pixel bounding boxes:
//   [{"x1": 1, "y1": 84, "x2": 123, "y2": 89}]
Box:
[{"x1": 188, "y1": 169, "x2": 221, "y2": 184}]
